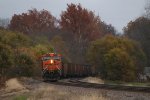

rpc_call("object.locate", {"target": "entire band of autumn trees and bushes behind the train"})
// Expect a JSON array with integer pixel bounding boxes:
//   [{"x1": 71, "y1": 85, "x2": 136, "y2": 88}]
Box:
[{"x1": 0, "y1": 4, "x2": 150, "y2": 81}]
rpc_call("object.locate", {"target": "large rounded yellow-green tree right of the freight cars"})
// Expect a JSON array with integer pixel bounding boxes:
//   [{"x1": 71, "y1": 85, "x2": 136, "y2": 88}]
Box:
[{"x1": 87, "y1": 35, "x2": 146, "y2": 80}]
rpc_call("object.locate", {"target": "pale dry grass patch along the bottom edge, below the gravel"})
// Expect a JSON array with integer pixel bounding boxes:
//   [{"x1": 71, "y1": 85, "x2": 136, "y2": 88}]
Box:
[{"x1": 28, "y1": 86, "x2": 108, "y2": 100}]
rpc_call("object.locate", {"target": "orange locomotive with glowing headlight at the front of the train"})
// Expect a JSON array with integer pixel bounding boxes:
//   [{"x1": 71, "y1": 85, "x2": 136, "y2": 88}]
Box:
[{"x1": 41, "y1": 53, "x2": 62, "y2": 80}]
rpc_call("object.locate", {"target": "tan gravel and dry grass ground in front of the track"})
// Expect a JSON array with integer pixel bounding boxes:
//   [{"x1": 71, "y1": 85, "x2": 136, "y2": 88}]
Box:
[{"x1": 0, "y1": 78, "x2": 150, "y2": 100}]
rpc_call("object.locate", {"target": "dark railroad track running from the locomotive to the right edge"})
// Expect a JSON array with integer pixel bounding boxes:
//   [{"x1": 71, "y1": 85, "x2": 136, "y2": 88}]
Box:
[{"x1": 45, "y1": 79, "x2": 150, "y2": 93}]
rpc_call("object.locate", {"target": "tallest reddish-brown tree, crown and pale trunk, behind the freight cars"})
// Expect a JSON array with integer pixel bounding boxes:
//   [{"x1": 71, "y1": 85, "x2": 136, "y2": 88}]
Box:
[{"x1": 60, "y1": 4, "x2": 116, "y2": 61}]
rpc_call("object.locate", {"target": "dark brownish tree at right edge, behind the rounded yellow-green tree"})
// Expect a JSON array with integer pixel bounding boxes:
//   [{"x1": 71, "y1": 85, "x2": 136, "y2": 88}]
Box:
[{"x1": 124, "y1": 17, "x2": 150, "y2": 66}]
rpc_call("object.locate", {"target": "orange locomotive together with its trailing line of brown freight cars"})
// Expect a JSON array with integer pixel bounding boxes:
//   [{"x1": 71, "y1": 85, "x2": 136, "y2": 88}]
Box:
[{"x1": 41, "y1": 53, "x2": 91, "y2": 80}]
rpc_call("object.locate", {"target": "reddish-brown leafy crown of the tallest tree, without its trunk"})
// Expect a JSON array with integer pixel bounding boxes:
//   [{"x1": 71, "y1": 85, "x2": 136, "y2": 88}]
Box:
[{"x1": 60, "y1": 4, "x2": 115, "y2": 42}]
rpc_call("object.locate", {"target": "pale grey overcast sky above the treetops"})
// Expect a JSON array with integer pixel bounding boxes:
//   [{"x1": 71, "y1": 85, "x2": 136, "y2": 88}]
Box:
[{"x1": 0, "y1": 0, "x2": 146, "y2": 32}]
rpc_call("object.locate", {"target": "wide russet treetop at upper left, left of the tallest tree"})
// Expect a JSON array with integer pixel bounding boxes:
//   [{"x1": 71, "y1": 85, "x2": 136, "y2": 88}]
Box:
[{"x1": 9, "y1": 9, "x2": 56, "y2": 35}]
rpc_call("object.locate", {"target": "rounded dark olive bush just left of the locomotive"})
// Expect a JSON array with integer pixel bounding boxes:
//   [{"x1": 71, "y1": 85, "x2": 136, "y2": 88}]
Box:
[{"x1": 12, "y1": 48, "x2": 37, "y2": 76}]
